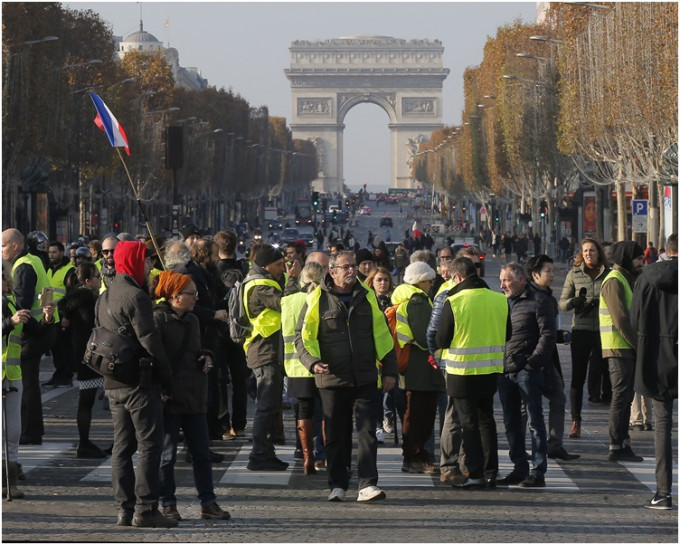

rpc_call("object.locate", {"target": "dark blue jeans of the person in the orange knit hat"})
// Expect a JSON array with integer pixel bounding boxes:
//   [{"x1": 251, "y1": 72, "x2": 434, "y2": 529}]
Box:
[{"x1": 160, "y1": 412, "x2": 215, "y2": 507}]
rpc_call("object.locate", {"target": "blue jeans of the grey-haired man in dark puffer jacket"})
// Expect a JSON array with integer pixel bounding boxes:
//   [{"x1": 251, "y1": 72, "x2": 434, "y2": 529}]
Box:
[{"x1": 498, "y1": 369, "x2": 548, "y2": 477}]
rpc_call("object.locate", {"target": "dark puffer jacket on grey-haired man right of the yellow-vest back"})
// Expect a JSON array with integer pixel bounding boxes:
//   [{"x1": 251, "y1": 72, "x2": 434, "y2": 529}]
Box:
[{"x1": 504, "y1": 284, "x2": 556, "y2": 374}]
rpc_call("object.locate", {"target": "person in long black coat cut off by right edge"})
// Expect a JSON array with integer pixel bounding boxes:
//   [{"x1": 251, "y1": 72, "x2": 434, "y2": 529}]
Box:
[{"x1": 630, "y1": 234, "x2": 678, "y2": 509}]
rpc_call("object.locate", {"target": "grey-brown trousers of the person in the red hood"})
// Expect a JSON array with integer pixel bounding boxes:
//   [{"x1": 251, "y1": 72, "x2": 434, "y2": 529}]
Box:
[{"x1": 106, "y1": 385, "x2": 163, "y2": 514}]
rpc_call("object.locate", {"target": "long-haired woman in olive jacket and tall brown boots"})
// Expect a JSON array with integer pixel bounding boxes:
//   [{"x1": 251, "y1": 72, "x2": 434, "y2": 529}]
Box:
[{"x1": 559, "y1": 237, "x2": 611, "y2": 439}]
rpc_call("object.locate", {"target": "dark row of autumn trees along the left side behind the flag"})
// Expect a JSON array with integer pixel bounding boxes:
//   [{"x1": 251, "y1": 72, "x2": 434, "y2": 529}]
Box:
[{"x1": 2, "y1": 2, "x2": 318, "y2": 241}]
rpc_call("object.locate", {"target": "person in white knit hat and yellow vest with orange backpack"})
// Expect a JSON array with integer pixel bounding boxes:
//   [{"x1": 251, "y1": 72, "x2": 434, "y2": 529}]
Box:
[{"x1": 392, "y1": 262, "x2": 446, "y2": 473}]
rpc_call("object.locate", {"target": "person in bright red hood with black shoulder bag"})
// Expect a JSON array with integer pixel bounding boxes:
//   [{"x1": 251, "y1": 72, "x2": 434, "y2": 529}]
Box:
[{"x1": 97, "y1": 241, "x2": 177, "y2": 528}]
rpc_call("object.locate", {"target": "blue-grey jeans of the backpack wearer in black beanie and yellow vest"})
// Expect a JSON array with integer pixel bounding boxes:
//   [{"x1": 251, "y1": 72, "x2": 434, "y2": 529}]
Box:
[{"x1": 250, "y1": 363, "x2": 283, "y2": 462}]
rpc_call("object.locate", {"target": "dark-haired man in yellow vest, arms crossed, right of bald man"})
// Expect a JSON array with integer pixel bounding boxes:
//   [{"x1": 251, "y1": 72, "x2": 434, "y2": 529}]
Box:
[{"x1": 43, "y1": 241, "x2": 76, "y2": 387}]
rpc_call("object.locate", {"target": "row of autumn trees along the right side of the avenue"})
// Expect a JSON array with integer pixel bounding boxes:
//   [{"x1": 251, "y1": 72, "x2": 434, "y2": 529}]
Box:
[{"x1": 413, "y1": 2, "x2": 678, "y2": 247}]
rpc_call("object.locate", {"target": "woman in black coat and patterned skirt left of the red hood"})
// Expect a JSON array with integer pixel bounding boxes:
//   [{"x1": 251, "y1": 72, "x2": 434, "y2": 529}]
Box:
[{"x1": 59, "y1": 262, "x2": 106, "y2": 458}]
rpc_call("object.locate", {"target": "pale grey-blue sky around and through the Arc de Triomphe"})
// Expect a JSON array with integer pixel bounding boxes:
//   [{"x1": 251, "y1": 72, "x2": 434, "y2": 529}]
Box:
[{"x1": 63, "y1": 1, "x2": 536, "y2": 191}]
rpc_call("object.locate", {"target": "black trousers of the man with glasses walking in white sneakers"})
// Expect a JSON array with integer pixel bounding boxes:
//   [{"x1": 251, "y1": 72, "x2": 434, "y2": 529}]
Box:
[{"x1": 319, "y1": 384, "x2": 382, "y2": 490}]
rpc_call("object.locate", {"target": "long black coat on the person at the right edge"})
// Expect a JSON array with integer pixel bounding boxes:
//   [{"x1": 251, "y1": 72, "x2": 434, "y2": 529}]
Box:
[{"x1": 630, "y1": 257, "x2": 678, "y2": 400}]
